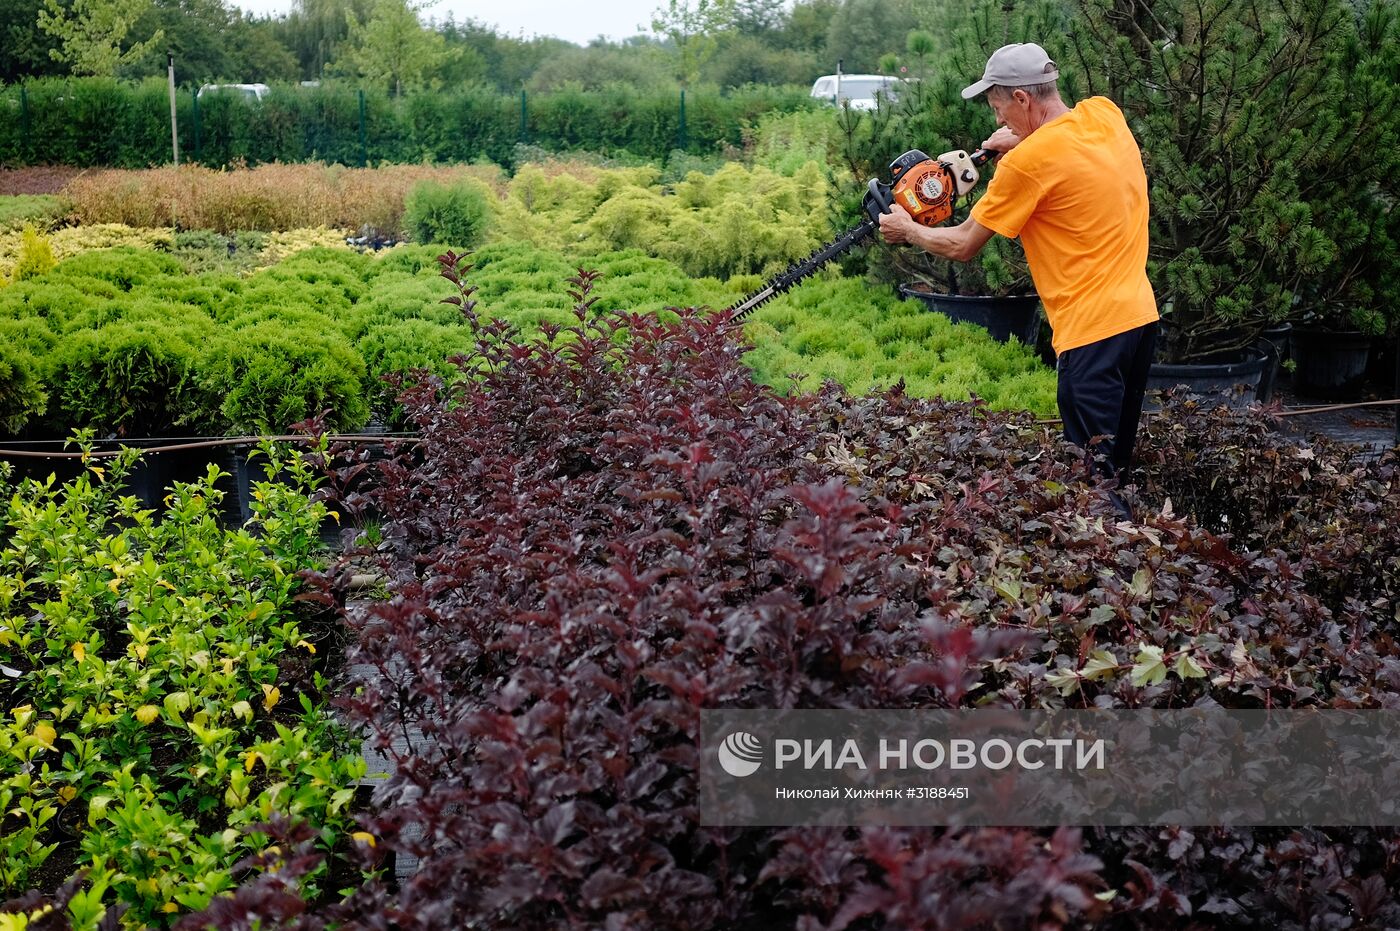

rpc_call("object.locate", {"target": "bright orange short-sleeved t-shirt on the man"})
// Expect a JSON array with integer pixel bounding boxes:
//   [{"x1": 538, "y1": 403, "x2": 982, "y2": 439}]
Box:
[{"x1": 972, "y1": 97, "x2": 1158, "y2": 353}]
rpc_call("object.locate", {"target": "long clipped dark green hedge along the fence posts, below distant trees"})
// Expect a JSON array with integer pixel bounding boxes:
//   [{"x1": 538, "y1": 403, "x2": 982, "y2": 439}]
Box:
[{"x1": 0, "y1": 78, "x2": 813, "y2": 168}]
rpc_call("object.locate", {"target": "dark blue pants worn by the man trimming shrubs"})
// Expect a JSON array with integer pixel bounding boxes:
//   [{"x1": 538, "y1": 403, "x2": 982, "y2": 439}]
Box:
[{"x1": 1056, "y1": 323, "x2": 1156, "y2": 476}]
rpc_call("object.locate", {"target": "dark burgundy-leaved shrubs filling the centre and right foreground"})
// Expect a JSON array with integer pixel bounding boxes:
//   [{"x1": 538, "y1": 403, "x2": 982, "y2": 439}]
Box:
[{"x1": 166, "y1": 261, "x2": 1400, "y2": 930}]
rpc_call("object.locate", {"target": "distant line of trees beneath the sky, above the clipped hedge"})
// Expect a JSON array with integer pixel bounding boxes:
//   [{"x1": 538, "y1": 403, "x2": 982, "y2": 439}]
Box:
[{"x1": 0, "y1": 0, "x2": 942, "y2": 94}]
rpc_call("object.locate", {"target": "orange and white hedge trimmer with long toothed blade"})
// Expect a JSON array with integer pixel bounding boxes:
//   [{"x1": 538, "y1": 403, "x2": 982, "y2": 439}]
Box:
[{"x1": 729, "y1": 148, "x2": 1000, "y2": 322}]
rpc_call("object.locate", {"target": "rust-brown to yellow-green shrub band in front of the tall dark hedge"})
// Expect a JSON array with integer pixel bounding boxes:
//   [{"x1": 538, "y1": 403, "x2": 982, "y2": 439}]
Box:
[{"x1": 54, "y1": 158, "x2": 827, "y2": 277}]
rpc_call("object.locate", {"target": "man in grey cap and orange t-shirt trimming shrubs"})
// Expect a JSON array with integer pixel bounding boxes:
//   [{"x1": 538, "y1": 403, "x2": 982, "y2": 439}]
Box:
[{"x1": 881, "y1": 43, "x2": 1158, "y2": 510}]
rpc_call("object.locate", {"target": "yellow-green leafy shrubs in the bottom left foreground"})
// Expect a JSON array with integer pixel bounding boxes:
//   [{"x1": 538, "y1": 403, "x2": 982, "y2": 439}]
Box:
[{"x1": 0, "y1": 447, "x2": 364, "y2": 928}]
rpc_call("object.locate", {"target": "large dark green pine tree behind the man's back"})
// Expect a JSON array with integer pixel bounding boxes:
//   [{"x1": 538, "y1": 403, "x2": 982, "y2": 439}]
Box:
[{"x1": 1061, "y1": 0, "x2": 1400, "y2": 361}]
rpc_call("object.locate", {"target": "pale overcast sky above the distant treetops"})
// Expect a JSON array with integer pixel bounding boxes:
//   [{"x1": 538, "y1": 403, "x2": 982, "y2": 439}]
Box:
[{"x1": 230, "y1": 0, "x2": 664, "y2": 45}]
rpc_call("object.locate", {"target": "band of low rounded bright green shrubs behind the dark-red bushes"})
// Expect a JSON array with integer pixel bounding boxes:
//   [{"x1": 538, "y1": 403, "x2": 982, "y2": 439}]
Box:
[{"x1": 0, "y1": 244, "x2": 1053, "y2": 437}]
